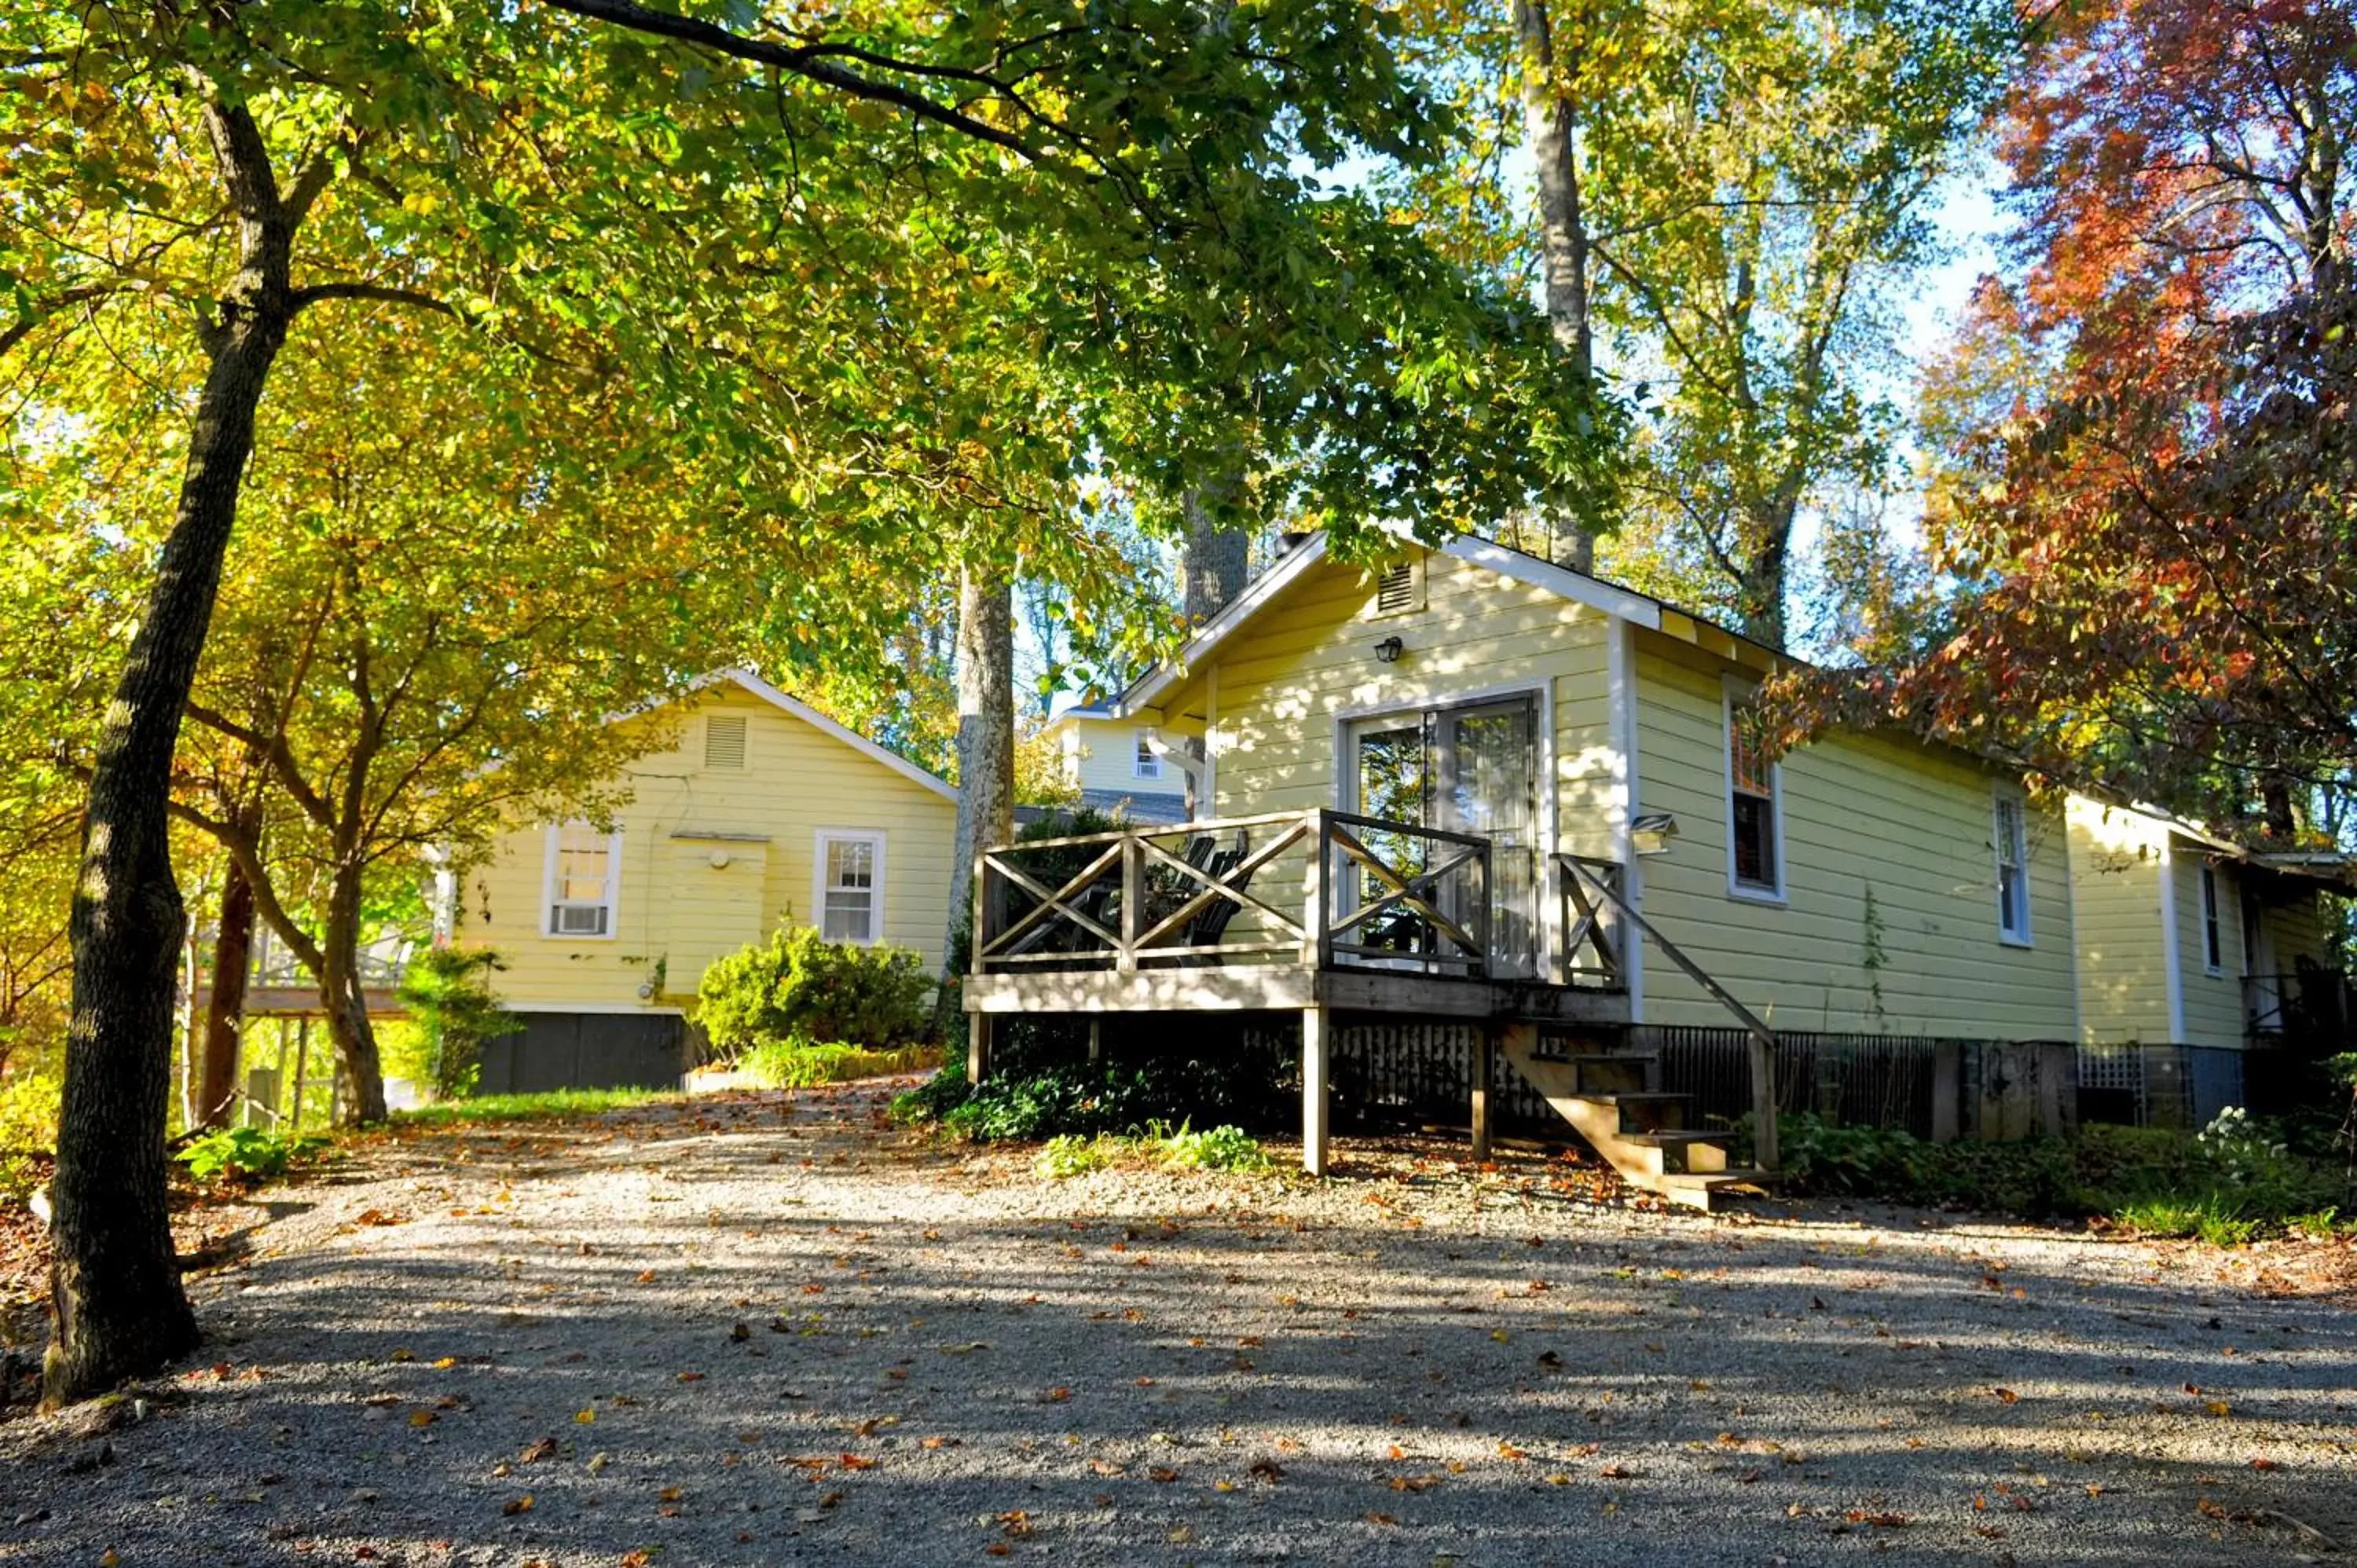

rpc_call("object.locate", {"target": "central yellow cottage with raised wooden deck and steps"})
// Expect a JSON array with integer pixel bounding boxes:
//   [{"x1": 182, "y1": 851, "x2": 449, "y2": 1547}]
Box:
[{"x1": 966, "y1": 537, "x2": 2079, "y2": 1200}]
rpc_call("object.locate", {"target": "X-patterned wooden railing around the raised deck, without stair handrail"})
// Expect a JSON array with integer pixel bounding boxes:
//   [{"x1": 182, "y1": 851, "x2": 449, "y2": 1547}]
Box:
[{"x1": 973, "y1": 809, "x2": 1490, "y2": 976}]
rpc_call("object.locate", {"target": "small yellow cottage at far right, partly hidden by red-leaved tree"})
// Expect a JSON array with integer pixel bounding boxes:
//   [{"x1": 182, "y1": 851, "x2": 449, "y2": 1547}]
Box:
[{"x1": 2067, "y1": 795, "x2": 2350, "y2": 1123}]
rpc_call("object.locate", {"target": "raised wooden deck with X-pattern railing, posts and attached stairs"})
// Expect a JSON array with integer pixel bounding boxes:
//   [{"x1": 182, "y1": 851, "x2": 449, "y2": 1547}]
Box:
[{"x1": 962, "y1": 809, "x2": 1775, "y2": 1188}]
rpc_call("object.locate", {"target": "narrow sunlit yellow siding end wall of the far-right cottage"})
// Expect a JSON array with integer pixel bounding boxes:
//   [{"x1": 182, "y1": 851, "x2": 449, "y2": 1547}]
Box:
[{"x1": 2067, "y1": 795, "x2": 2173, "y2": 1045}]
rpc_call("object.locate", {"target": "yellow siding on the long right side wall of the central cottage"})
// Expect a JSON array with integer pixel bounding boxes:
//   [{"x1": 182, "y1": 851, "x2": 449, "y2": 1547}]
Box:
[{"x1": 1636, "y1": 632, "x2": 2074, "y2": 1040}]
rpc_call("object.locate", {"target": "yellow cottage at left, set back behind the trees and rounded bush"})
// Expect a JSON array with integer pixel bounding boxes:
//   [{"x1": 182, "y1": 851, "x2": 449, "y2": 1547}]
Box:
[{"x1": 455, "y1": 669, "x2": 957, "y2": 1094}]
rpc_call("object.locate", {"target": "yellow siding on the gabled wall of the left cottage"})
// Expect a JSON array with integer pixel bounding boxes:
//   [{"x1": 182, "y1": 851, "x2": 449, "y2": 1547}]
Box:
[{"x1": 460, "y1": 686, "x2": 957, "y2": 1012}]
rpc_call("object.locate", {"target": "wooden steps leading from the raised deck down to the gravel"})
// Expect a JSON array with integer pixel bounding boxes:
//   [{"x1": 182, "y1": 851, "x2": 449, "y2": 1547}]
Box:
[{"x1": 1499, "y1": 1024, "x2": 1765, "y2": 1212}]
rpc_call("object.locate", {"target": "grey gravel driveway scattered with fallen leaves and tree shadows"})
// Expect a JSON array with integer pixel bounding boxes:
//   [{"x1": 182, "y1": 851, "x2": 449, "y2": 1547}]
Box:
[{"x1": 0, "y1": 1087, "x2": 2357, "y2": 1568}]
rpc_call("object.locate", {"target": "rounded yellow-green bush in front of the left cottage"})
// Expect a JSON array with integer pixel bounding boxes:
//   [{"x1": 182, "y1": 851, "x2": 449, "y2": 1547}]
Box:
[{"x1": 695, "y1": 927, "x2": 933, "y2": 1061}]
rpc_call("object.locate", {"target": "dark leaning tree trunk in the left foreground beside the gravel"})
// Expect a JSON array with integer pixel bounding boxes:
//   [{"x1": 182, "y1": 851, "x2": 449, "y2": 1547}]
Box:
[{"x1": 42, "y1": 104, "x2": 295, "y2": 1403}]
